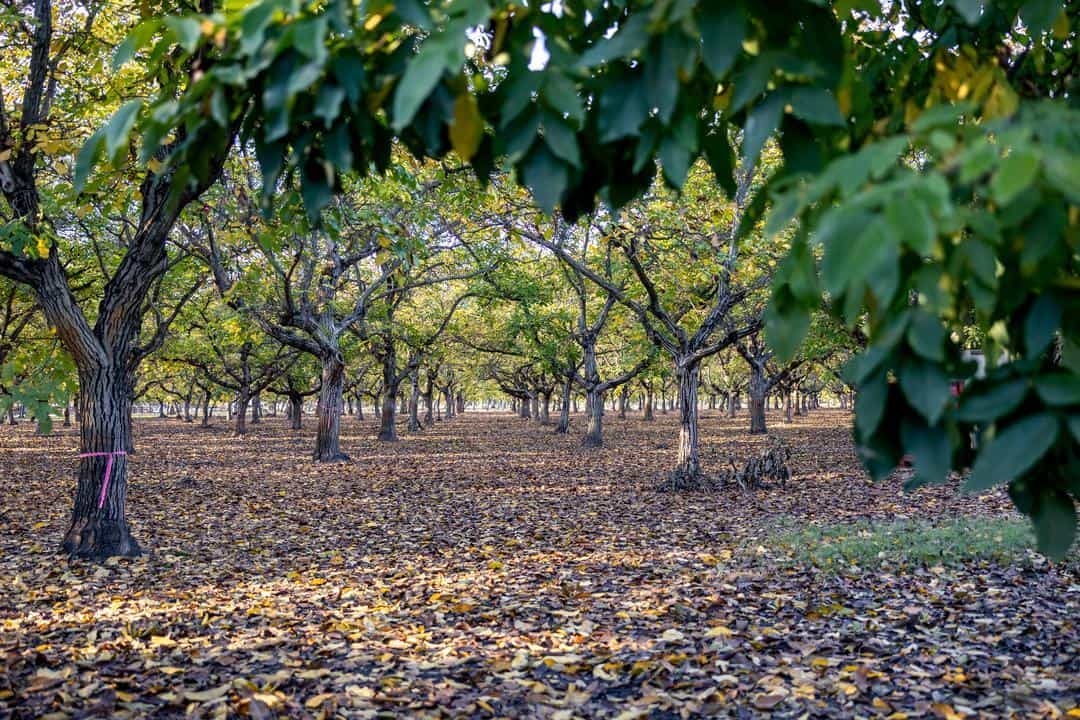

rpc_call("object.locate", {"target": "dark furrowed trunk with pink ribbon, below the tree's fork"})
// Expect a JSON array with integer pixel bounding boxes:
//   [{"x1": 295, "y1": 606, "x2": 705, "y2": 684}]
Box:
[{"x1": 63, "y1": 366, "x2": 141, "y2": 561}]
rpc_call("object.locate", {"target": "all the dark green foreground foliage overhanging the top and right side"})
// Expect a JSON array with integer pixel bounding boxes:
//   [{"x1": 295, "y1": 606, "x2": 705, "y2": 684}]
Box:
[{"x1": 77, "y1": 0, "x2": 1080, "y2": 556}]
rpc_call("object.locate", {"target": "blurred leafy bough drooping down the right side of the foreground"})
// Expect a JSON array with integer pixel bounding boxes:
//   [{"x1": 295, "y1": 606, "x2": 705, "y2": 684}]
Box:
[{"x1": 768, "y1": 103, "x2": 1080, "y2": 556}]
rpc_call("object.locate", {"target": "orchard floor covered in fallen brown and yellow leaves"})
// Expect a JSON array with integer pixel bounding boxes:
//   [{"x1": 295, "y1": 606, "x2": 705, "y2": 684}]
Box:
[{"x1": 0, "y1": 410, "x2": 1080, "y2": 718}]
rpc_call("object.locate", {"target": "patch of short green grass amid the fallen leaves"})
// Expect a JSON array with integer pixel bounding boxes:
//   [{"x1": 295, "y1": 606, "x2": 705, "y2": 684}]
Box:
[{"x1": 771, "y1": 517, "x2": 1058, "y2": 569}]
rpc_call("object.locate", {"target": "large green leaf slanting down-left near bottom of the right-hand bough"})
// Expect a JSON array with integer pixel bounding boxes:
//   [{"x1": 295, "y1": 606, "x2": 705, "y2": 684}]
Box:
[{"x1": 964, "y1": 415, "x2": 1058, "y2": 492}]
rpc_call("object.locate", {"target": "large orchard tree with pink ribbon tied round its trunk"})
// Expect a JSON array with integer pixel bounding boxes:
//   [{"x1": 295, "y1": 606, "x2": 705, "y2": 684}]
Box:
[{"x1": 0, "y1": 0, "x2": 235, "y2": 559}]
